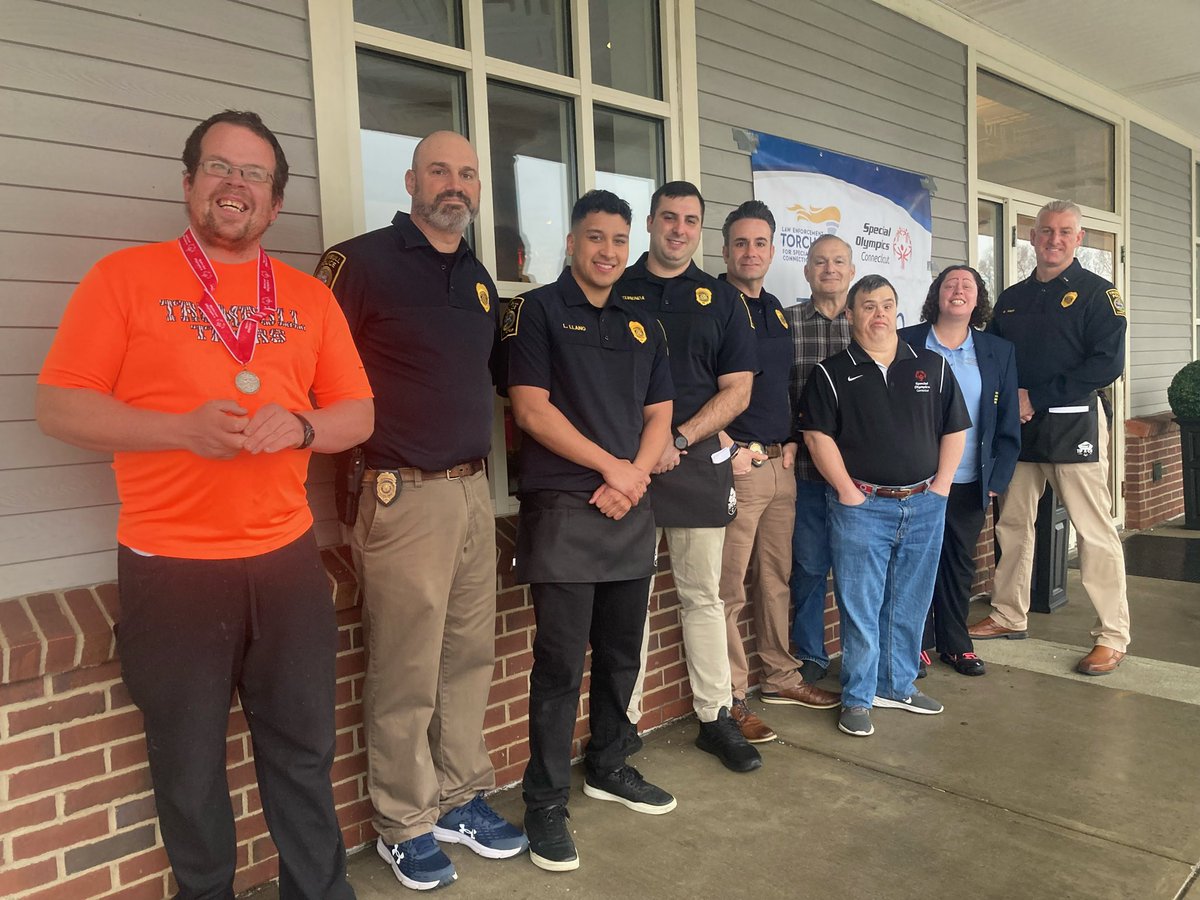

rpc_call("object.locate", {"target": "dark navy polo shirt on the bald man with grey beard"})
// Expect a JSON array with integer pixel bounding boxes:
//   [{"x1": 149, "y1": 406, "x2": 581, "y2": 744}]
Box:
[{"x1": 317, "y1": 212, "x2": 498, "y2": 470}]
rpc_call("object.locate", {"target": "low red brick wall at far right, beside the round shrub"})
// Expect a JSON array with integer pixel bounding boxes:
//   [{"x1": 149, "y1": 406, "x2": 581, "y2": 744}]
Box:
[{"x1": 1124, "y1": 413, "x2": 1183, "y2": 529}]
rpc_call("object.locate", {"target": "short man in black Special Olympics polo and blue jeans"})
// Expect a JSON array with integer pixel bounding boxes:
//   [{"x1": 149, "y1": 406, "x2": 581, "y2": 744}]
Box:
[{"x1": 798, "y1": 275, "x2": 971, "y2": 737}]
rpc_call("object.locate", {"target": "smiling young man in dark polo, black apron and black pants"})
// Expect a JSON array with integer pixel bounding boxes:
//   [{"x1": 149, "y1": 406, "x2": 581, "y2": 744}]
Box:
[{"x1": 503, "y1": 191, "x2": 676, "y2": 871}]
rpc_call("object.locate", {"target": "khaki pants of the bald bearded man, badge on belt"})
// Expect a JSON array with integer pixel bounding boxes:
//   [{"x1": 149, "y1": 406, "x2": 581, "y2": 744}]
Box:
[{"x1": 353, "y1": 472, "x2": 496, "y2": 844}]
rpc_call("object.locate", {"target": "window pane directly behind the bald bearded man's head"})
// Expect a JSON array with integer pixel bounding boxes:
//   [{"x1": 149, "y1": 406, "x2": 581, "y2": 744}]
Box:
[{"x1": 358, "y1": 50, "x2": 467, "y2": 229}]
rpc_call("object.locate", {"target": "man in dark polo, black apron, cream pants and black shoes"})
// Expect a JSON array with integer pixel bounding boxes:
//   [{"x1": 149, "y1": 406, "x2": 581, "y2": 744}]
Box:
[{"x1": 617, "y1": 181, "x2": 762, "y2": 772}]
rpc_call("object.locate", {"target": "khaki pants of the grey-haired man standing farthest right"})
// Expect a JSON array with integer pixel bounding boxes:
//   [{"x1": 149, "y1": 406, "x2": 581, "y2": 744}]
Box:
[{"x1": 991, "y1": 414, "x2": 1129, "y2": 653}]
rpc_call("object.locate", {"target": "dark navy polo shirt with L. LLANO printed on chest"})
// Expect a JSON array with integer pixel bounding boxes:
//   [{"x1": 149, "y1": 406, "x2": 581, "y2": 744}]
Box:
[{"x1": 503, "y1": 268, "x2": 674, "y2": 493}]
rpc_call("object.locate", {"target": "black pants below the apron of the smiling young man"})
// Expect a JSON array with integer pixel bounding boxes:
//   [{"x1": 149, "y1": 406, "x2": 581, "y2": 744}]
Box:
[{"x1": 522, "y1": 577, "x2": 650, "y2": 809}]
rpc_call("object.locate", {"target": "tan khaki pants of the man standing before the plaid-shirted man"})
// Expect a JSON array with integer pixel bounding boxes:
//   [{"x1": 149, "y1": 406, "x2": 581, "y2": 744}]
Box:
[{"x1": 721, "y1": 457, "x2": 802, "y2": 700}]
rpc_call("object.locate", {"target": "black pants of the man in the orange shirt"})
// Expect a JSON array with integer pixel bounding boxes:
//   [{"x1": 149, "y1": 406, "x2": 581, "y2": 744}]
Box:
[{"x1": 116, "y1": 530, "x2": 354, "y2": 900}]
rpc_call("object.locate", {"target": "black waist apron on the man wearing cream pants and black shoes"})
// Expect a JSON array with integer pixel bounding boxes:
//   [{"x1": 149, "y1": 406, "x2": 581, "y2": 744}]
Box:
[{"x1": 648, "y1": 434, "x2": 738, "y2": 528}]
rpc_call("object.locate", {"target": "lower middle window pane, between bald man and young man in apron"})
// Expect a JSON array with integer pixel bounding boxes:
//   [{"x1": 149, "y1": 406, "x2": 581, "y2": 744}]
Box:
[{"x1": 485, "y1": 83, "x2": 578, "y2": 284}]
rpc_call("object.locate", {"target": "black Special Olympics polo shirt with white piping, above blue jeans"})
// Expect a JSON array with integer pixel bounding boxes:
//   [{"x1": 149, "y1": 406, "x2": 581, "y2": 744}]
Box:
[{"x1": 798, "y1": 341, "x2": 971, "y2": 487}]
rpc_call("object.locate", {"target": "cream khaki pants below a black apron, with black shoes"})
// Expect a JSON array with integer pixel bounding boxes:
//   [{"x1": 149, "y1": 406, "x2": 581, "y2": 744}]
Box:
[{"x1": 629, "y1": 528, "x2": 733, "y2": 725}]
